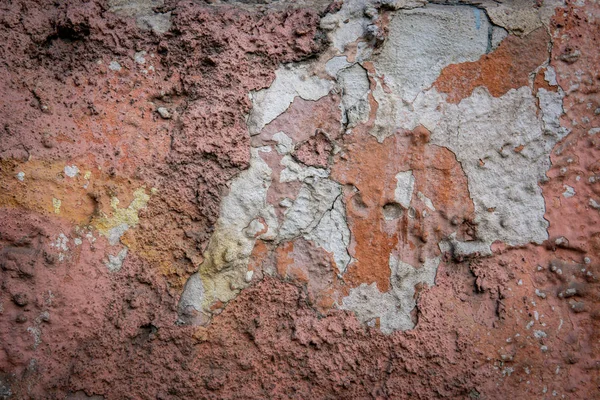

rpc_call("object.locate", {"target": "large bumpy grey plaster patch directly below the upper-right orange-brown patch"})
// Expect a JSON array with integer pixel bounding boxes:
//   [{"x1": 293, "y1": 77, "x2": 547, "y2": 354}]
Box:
[{"x1": 431, "y1": 87, "x2": 558, "y2": 245}]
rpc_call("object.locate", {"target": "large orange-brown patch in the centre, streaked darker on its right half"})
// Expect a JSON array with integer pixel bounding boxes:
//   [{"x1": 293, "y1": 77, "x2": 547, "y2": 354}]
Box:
[{"x1": 332, "y1": 127, "x2": 473, "y2": 292}]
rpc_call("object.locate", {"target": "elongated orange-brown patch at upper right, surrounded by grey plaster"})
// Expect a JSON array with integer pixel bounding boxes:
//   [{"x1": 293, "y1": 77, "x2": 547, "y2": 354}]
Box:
[{"x1": 434, "y1": 28, "x2": 550, "y2": 103}]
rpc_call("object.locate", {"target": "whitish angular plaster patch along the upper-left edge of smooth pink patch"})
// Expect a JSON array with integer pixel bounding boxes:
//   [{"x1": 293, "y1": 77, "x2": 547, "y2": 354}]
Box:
[{"x1": 248, "y1": 64, "x2": 333, "y2": 135}]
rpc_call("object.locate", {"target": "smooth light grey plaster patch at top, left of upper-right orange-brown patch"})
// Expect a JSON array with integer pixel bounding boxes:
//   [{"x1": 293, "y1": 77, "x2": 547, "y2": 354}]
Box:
[{"x1": 375, "y1": 5, "x2": 491, "y2": 102}]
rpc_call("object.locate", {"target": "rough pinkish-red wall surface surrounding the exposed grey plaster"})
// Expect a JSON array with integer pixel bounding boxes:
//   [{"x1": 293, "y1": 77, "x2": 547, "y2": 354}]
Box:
[{"x1": 0, "y1": 0, "x2": 600, "y2": 399}]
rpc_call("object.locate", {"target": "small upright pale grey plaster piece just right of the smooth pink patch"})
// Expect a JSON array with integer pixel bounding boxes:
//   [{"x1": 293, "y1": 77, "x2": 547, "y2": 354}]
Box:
[{"x1": 337, "y1": 64, "x2": 371, "y2": 128}]
